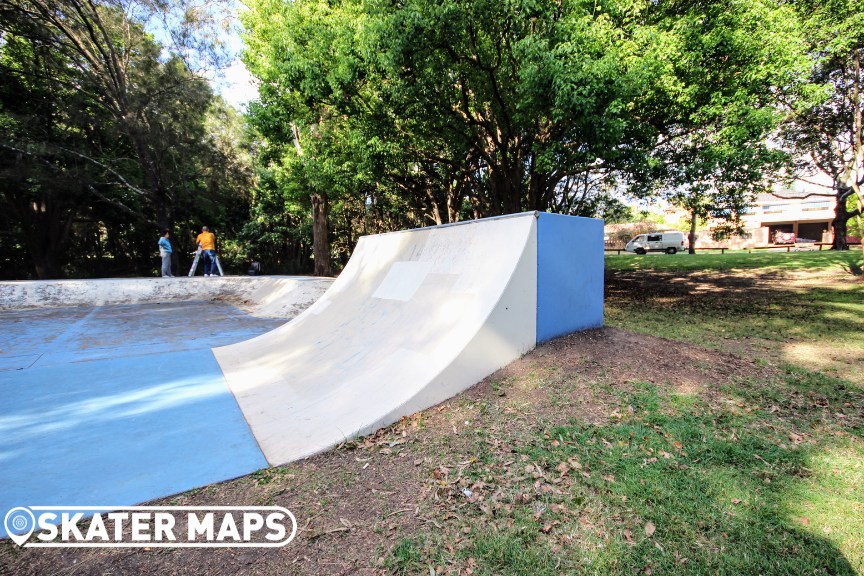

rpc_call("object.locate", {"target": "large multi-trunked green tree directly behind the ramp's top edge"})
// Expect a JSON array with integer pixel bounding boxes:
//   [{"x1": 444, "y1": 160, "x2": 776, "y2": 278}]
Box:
[{"x1": 352, "y1": 0, "x2": 657, "y2": 217}]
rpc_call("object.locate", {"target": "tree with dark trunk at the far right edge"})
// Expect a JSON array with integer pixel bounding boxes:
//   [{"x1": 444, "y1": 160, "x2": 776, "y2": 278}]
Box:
[{"x1": 783, "y1": 0, "x2": 864, "y2": 250}]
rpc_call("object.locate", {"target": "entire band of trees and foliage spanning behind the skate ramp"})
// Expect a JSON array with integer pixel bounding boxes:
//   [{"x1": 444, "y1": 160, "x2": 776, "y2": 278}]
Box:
[{"x1": 0, "y1": 0, "x2": 864, "y2": 277}]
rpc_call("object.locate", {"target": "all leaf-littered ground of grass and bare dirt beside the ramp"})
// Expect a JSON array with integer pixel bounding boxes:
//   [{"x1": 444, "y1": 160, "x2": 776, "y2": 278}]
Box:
[{"x1": 6, "y1": 252, "x2": 864, "y2": 576}]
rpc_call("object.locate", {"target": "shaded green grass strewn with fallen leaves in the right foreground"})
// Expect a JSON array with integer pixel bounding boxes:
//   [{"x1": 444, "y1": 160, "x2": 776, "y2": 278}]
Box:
[{"x1": 387, "y1": 375, "x2": 864, "y2": 575}]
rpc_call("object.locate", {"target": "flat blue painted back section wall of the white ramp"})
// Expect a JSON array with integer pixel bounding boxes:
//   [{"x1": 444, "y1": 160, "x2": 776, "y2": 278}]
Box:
[{"x1": 537, "y1": 212, "x2": 603, "y2": 344}]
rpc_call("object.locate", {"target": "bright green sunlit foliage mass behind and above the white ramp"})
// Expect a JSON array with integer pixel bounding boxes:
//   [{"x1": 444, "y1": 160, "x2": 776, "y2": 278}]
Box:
[{"x1": 244, "y1": 0, "x2": 803, "y2": 260}]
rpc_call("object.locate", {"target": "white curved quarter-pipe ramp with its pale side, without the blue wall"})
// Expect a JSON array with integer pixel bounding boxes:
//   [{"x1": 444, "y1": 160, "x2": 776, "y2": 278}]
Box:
[{"x1": 214, "y1": 213, "x2": 540, "y2": 465}]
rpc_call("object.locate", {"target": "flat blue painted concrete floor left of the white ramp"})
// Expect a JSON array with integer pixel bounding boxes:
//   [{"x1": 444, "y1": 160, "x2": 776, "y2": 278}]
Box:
[{"x1": 0, "y1": 302, "x2": 281, "y2": 535}]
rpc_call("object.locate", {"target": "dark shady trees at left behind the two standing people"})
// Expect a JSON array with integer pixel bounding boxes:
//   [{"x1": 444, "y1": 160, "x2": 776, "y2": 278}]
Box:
[{"x1": 0, "y1": 0, "x2": 253, "y2": 278}]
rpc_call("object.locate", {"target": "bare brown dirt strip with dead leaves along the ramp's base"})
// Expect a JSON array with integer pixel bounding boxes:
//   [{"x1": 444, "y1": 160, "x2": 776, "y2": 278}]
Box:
[{"x1": 0, "y1": 328, "x2": 763, "y2": 575}]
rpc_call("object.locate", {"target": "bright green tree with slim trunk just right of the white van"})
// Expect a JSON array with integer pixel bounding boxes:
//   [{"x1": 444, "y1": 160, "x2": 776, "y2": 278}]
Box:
[{"x1": 630, "y1": 1, "x2": 806, "y2": 254}]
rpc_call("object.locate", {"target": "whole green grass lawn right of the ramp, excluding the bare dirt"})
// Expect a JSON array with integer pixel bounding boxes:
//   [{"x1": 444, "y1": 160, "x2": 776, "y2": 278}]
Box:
[{"x1": 387, "y1": 252, "x2": 864, "y2": 574}]
